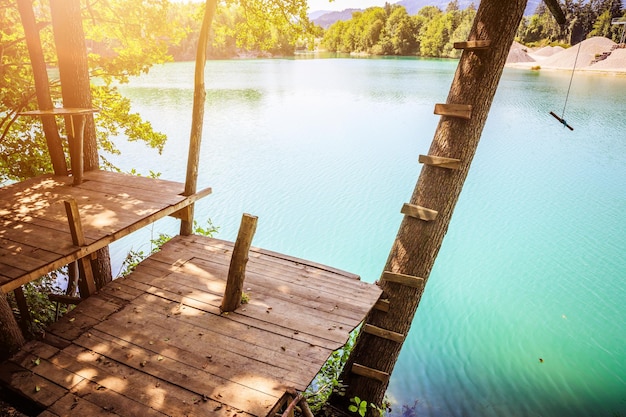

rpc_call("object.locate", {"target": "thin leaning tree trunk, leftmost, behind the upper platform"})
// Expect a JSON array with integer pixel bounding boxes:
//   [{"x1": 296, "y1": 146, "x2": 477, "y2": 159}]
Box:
[{"x1": 17, "y1": 0, "x2": 67, "y2": 175}]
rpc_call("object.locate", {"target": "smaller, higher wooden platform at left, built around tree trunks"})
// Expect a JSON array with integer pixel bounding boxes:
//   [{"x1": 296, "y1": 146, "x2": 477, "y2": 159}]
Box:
[{"x1": 0, "y1": 171, "x2": 211, "y2": 293}]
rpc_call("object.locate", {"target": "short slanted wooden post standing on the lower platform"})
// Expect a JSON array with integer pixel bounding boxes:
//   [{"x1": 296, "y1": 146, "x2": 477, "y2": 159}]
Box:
[{"x1": 220, "y1": 213, "x2": 258, "y2": 313}]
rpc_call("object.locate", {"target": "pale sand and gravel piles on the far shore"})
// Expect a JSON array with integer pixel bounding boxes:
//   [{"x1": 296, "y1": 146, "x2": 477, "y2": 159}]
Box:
[{"x1": 507, "y1": 36, "x2": 626, "y2": 72}]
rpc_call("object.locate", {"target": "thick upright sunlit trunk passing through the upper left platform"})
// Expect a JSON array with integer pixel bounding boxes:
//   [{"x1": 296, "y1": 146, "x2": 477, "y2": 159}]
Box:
[{"x1": 50, "y1": 0, "x2": 112, "y2": 288}]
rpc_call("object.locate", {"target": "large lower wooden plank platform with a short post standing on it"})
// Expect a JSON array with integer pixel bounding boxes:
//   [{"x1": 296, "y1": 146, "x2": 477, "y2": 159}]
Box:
[{"x1": 0, "y1": 236, "x2": 381, "y2": 417}]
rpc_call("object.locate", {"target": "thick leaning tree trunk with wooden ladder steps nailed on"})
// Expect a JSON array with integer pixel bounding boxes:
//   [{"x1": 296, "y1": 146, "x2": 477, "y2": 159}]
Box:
[{"x1": 331, "y1": 0, "x2": 526, "y2": 409}]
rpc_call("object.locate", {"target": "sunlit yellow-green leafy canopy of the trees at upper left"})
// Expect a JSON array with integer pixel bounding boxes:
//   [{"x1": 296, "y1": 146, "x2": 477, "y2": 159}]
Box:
[{"x1": 0, "y1": 0, "x2": 316, "y2": 183}]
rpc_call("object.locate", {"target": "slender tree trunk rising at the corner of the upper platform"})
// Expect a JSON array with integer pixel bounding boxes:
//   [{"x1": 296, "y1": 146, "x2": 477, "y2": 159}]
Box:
[{"x1": 180, "y1": 0, "x2": 217, "y2": 236}]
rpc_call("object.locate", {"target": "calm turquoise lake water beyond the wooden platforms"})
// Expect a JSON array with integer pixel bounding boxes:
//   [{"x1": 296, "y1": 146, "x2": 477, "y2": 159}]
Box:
[{"x1": 112, "y1": 59, "x2": 626, "y2": 417}]
